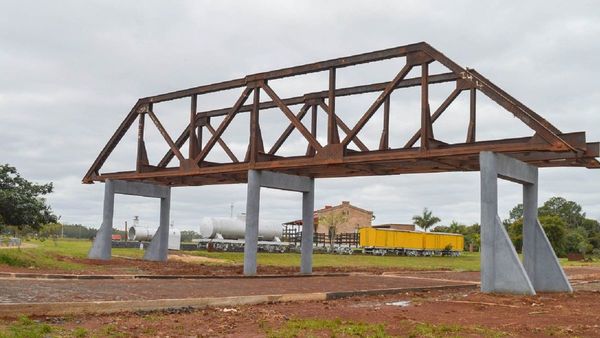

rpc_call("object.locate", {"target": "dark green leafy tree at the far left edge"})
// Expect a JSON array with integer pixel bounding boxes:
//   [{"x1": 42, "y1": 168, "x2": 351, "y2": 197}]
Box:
[{"x1": 0, "y1": 164, "x2": 58, "y2": 229}]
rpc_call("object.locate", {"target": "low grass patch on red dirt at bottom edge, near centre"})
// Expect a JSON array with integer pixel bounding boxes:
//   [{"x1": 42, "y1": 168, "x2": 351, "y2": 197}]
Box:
[{"x1": 263, "y1": 319, "x2": 390, "y2": 338}]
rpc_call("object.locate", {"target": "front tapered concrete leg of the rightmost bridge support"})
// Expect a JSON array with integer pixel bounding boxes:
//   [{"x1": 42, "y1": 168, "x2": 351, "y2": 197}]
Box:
[{"x1": 479, "y1": 152, "x2": 535, "y2": 295}]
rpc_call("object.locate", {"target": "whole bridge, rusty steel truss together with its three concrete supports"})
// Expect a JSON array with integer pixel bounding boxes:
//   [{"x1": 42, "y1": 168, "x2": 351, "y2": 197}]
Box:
[{"x1": 83, "y1": 42, "x2": 600, "y2": 294}]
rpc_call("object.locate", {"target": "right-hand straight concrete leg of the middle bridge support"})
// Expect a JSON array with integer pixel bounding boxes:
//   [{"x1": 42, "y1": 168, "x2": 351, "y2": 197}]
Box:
[{"x1": 300, "y1": 179, "x2": 315, "y2": 274}]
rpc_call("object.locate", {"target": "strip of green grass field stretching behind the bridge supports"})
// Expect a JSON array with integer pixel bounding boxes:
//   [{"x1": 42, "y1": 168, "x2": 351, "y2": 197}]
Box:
[{"x1": 0, "y1": 239, "x2": 600, "y2": 271}]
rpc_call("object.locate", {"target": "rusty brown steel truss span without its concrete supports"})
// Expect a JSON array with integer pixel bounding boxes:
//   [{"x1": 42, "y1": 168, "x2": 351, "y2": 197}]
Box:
[{"x1": 83, "y1": 42, "x2": 600, "y2": 186}]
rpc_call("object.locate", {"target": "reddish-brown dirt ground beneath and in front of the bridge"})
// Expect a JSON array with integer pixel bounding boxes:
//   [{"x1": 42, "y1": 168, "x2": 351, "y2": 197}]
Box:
[{"x1": 0, "y1": 258, "x2": 600, "y2": 337}]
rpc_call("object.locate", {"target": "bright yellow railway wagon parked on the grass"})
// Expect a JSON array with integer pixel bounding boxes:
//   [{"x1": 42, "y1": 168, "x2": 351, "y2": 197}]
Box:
[{"x1": 359, "y1": 228, "x2": 464, "y2": 255}]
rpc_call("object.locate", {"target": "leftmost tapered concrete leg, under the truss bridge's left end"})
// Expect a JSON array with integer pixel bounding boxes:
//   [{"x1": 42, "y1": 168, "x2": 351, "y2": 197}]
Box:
[{"x1": 88, "y1": 180, "x2": 115, "y2": 260}]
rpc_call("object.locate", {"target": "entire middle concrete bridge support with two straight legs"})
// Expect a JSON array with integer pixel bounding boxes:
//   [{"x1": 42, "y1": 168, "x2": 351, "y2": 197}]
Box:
[{"x1": 244, "y1": 170, "x2": 315, "y2": 276}]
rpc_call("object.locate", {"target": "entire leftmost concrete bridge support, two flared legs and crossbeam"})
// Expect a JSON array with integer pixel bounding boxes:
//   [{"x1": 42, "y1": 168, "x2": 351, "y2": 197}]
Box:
[{"x1": 88, "y1": 180, "x2": 171, "y2": 261}]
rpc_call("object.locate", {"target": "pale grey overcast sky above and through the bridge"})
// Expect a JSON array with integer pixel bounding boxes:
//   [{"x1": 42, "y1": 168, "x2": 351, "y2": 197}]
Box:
[{"x1": 0, "y1": 0, "x2": 600, "y2": 230}]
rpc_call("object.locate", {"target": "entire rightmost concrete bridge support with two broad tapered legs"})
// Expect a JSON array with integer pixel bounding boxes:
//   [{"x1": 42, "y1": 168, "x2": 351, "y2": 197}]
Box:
[{"x1": 479, "y1": 152, "x2": 573, "y2": 295}]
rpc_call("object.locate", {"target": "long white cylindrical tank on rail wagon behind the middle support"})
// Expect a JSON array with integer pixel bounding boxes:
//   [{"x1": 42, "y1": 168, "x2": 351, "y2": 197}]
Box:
[{"x1": 200, "y1": 217, "x2": 282, "y2": 241}]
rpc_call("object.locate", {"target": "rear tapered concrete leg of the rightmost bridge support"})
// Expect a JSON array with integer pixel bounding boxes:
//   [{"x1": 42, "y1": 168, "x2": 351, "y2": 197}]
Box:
[{"x1": 523, "y1": 182, "x2": 573, "y2": 292}]
